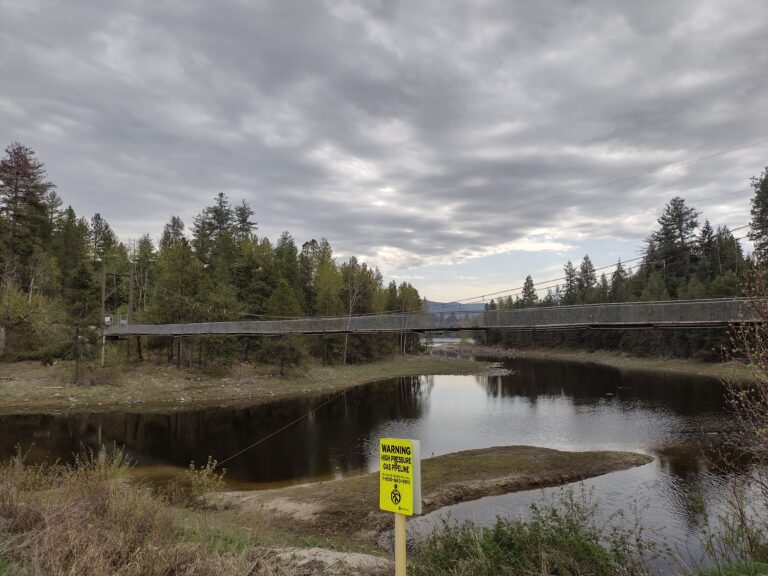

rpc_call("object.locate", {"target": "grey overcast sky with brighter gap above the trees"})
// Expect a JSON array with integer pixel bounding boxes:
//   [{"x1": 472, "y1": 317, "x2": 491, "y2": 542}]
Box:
[{"x1": 0, "y1": 0, "x2": 768, "y2": 301}]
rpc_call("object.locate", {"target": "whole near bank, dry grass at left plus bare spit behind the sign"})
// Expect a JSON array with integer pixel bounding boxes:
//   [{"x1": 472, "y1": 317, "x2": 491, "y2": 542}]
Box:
[{"x1": 0, "y1": 446, "x2": 648, "y2": 576}]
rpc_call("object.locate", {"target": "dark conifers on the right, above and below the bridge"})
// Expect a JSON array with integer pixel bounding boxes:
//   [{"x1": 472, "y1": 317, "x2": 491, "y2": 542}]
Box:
[{"x1": 486, "y1": 168, "x2": 768, "y2": 359}]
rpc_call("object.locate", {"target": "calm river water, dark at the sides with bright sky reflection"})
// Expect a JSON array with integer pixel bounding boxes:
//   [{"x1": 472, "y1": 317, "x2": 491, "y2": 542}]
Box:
[{"x1": 0, "y1": 360, "x2": 744, "y2": 572}]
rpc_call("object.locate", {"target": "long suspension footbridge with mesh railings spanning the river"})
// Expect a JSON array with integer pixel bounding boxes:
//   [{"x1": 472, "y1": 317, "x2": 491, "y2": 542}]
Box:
[{"x1": 106, "y1": 298, "x2": 761, "y2": 338}]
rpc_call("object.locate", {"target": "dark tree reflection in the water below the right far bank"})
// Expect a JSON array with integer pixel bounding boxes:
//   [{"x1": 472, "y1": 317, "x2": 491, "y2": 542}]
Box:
[{"x1": 477, "y1": 358, "x2": 726, "y2": 415}]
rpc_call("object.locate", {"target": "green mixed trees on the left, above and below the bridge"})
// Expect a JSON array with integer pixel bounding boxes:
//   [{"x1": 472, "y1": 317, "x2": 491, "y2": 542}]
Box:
[{"x1": 0, "y1": 143, "x2": 423, "y2": 367}]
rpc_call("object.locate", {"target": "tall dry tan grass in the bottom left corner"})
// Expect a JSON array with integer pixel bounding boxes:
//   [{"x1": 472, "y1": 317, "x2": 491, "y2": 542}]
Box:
[{"x1": 0, "y1": 451, "x2": 286, "y2": 576}]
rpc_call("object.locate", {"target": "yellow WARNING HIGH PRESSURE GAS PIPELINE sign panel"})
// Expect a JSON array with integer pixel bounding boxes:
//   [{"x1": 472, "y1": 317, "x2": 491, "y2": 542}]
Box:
[{"x1": 379, "y1": 438, "x2": 421, "y2": 516}]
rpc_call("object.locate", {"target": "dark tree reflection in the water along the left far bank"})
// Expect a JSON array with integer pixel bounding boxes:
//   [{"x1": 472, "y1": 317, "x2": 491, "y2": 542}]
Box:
[{"x1": 0, "y1": 377, "x2": 434, "y2": 482}]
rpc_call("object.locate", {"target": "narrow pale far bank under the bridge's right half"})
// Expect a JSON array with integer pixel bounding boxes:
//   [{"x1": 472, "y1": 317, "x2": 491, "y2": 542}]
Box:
[{"x1": 437, "y1": 344, "x2": 754, "y2": 382}]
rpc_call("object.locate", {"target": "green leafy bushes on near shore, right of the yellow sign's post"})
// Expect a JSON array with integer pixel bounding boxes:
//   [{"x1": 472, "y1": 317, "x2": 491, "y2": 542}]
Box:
[{"x1": 413, "y1": 489, "x2": 651, "y2": 576}]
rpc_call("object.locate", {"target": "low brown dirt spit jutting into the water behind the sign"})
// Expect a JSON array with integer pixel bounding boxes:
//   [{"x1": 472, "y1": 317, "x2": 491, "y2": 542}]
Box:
[{"x1": 212, "y1": 446, "x2": 652, "y2": 544}]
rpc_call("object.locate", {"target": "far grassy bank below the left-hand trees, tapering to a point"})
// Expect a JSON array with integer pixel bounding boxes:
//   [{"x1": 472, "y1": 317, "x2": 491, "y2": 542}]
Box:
[{"x1": 0, "y1": 356, "x2": 492, "y2": 414}]
